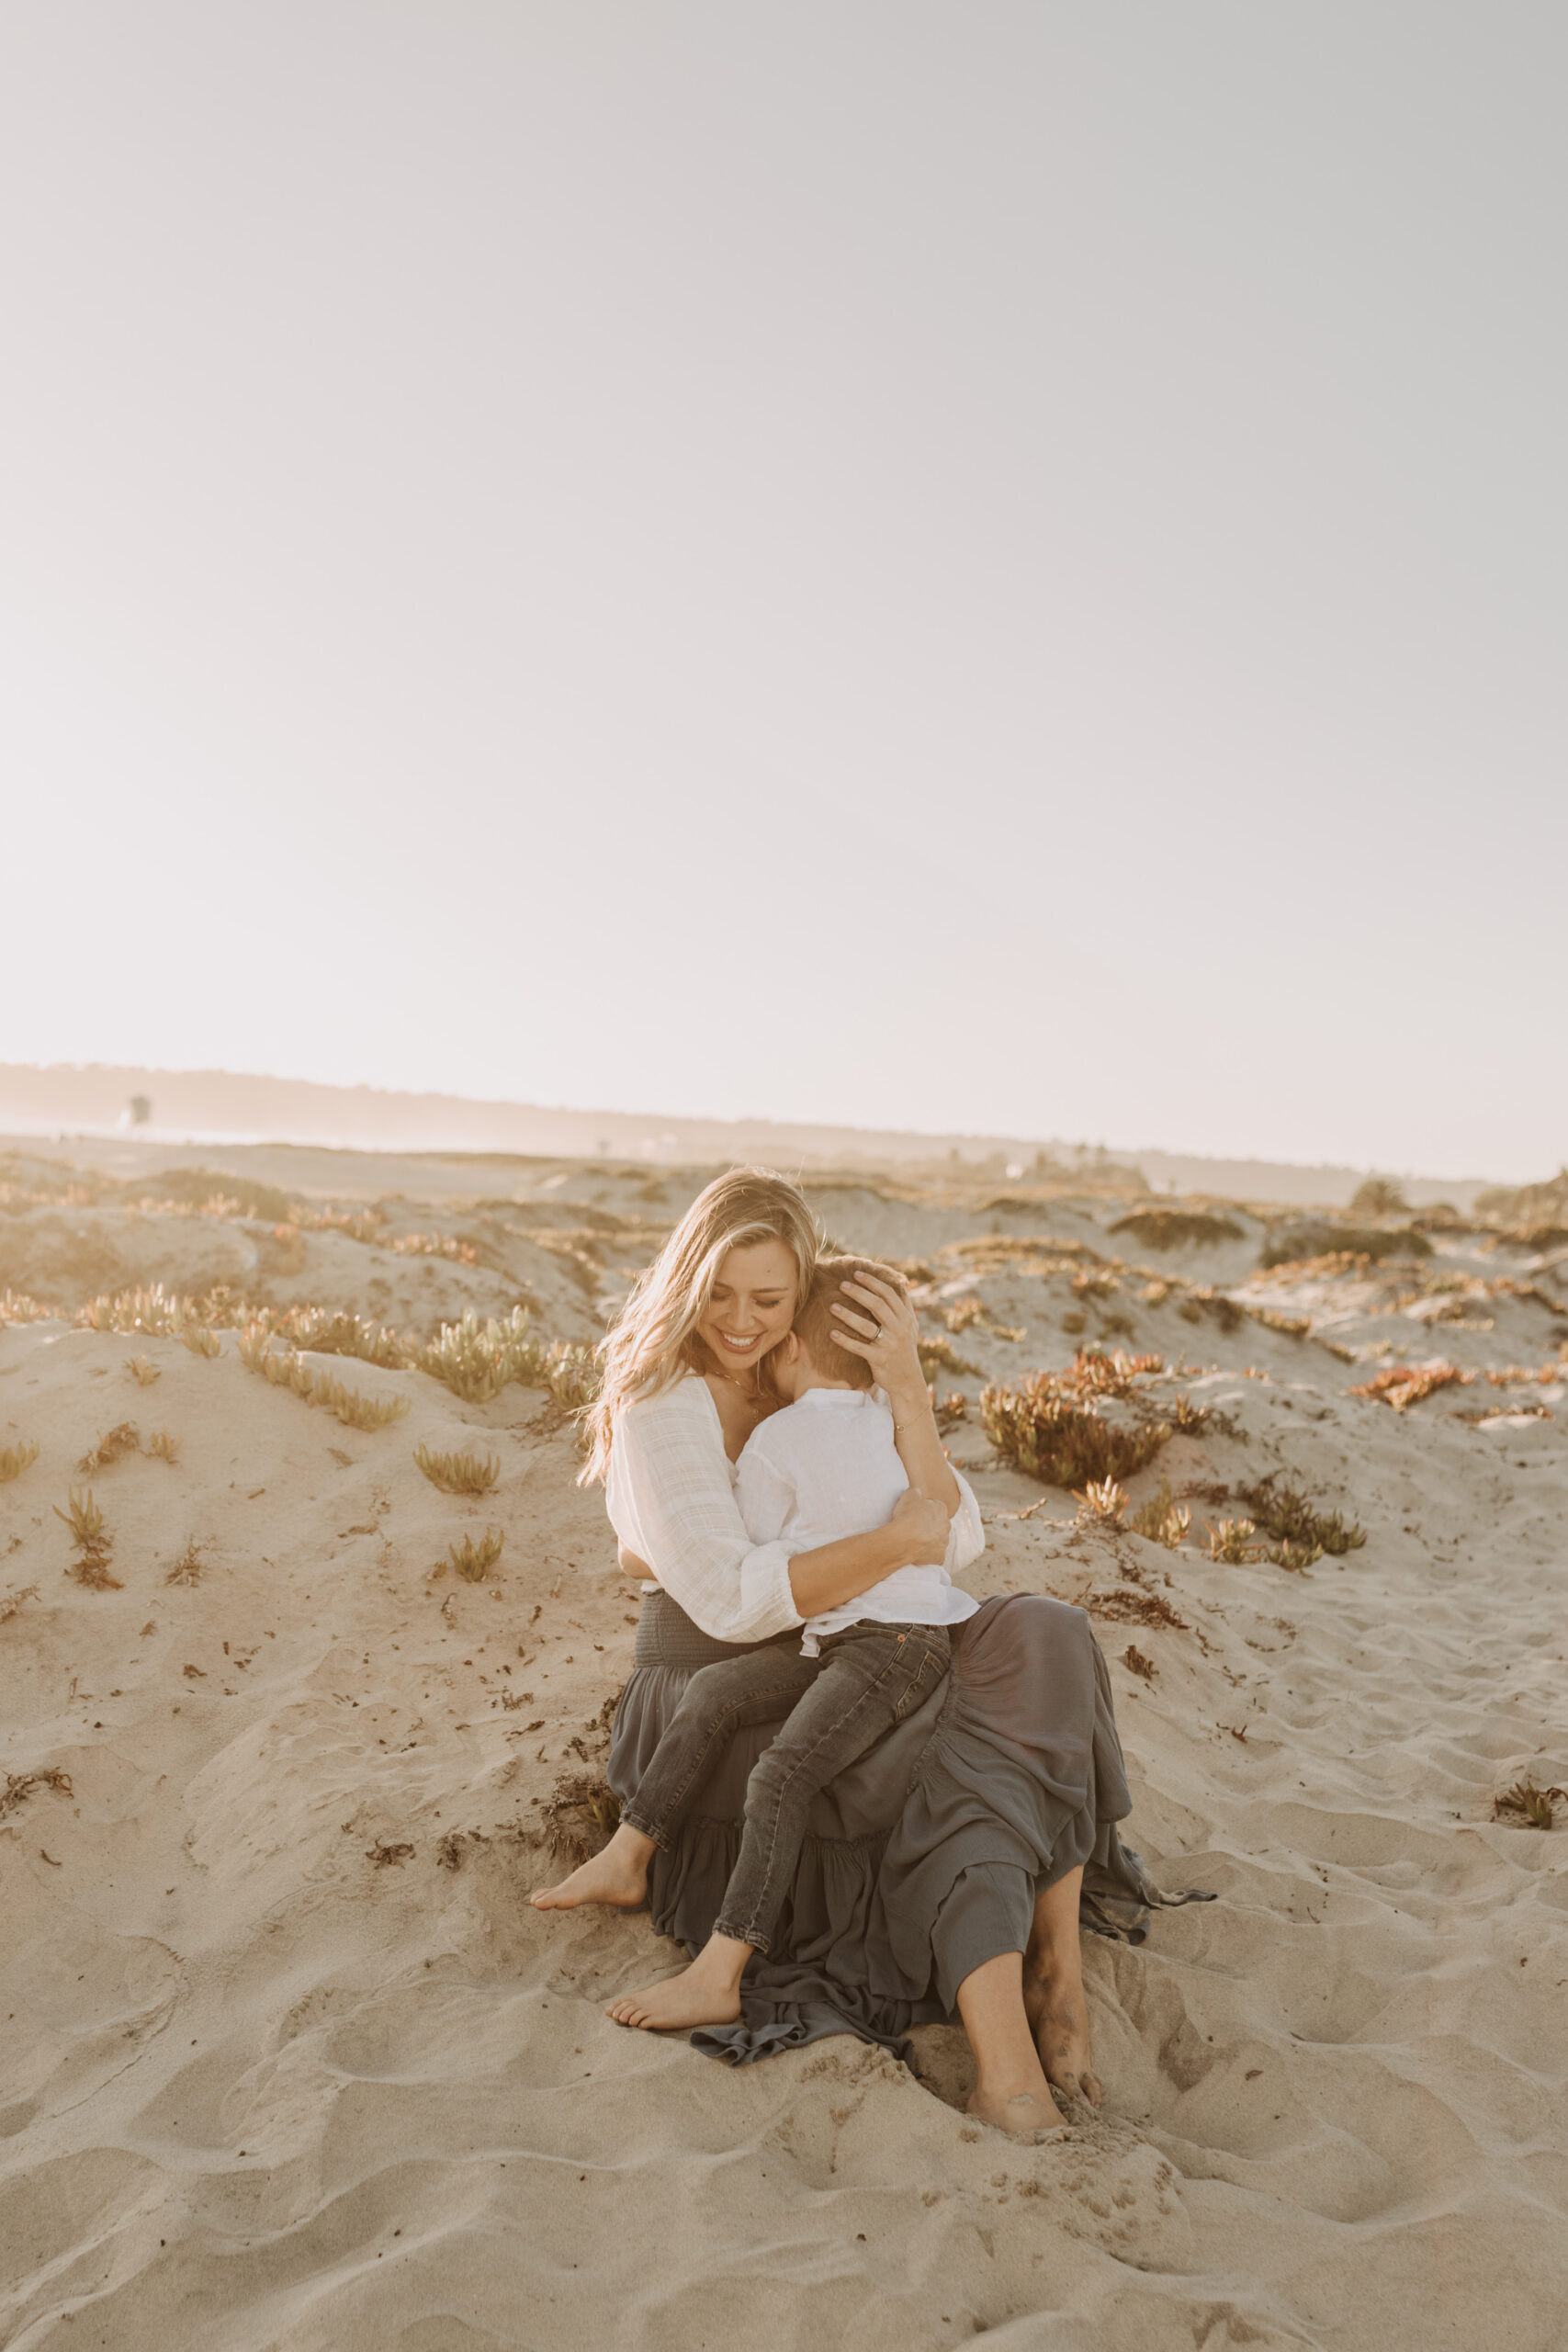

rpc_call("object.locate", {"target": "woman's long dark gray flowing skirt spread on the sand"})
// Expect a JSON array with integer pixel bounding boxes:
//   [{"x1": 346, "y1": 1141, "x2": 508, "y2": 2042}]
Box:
[{"x1": 609, "y1": 1592, "x2": 1208, "y2": 2065}]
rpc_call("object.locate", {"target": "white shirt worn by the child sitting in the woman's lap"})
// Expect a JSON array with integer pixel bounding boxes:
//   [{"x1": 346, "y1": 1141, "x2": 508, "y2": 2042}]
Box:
[{"x1": 736, "y1": 1387, "x2": 980, "y2": 1658}]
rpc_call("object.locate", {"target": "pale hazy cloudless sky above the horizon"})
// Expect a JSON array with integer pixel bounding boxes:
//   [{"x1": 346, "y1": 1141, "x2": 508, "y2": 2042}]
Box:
[{"x1": 0, "y1": 0, "x2": 1568, "y2": 1176}]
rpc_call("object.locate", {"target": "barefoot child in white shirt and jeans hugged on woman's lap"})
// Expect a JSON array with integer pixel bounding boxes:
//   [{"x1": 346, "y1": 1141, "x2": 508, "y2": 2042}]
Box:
[{"x1": 534, "y1": 1259, "x2": 978, "y2": 2028}]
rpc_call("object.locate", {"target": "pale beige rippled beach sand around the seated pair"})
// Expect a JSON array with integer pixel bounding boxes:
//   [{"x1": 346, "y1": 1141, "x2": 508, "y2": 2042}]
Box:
[{"x1": 0, "y1": 1162, "x2": 1568, "y2": 2352}]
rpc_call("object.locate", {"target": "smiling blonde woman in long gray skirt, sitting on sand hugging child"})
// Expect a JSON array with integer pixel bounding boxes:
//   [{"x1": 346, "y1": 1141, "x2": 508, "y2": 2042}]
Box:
[{"x1": 534, "y1": 1169, "x2": 1203, "y2": 2131}]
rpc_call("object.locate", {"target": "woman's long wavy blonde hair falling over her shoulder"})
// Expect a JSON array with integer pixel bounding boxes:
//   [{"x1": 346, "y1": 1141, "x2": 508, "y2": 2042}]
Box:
[{"x1": 579, "y1": 1169, "x2": 820, "y2": 1487}]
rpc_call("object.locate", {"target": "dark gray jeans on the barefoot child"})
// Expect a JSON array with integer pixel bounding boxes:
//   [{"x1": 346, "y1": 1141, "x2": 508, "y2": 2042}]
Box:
[{"x1": 621, "y1": 1621, "x2": 950, "y2": 1952}]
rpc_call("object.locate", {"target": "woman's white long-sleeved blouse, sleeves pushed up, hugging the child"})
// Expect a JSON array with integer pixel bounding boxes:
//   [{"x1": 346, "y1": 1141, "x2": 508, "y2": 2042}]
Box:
[{"x1": 604, "y1": 1371, "x2": 985, "y2": 1642}]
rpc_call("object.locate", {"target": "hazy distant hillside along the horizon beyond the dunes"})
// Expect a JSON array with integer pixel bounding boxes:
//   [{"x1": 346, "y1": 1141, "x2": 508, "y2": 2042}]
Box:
[{"x1": 0, "y1": 1063, "x2": 1483, "y2": 1209}]
